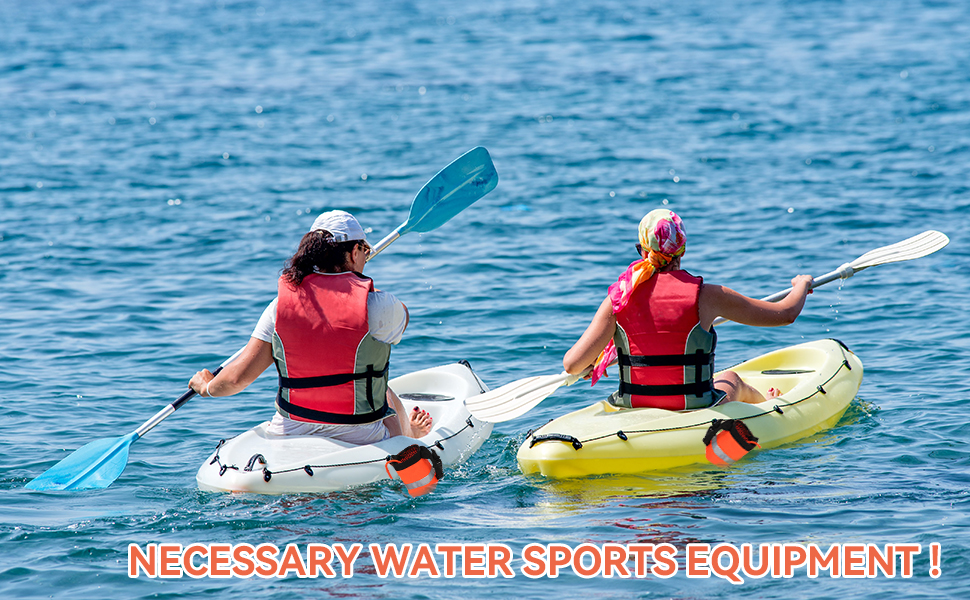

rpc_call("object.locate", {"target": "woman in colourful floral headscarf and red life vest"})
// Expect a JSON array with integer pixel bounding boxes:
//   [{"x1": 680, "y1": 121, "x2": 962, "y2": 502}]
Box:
[{"x1": 563, "y1": 209, "x2": 812, "y2": 410}]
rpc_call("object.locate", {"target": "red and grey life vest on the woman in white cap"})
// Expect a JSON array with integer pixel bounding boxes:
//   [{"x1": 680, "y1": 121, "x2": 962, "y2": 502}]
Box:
[{"x1": 273, "y1": 271, "x2": 391, "y2": 425}]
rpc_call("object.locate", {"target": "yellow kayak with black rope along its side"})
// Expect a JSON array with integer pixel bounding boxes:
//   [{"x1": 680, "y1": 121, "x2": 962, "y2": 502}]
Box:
[{"x1": 517, "y1": 340, "x2": 862, "y2": 478}]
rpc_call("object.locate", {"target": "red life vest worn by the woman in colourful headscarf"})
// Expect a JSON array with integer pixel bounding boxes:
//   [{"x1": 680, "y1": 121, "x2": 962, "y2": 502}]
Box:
[{"x1": 610, "y1": 271, "x2": 717, "y2": 410}]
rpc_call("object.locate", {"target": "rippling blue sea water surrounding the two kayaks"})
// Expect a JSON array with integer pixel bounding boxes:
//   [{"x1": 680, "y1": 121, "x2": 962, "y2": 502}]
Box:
[{"x1": 0, "y1": 0, "x2": 970, "y2": 599}]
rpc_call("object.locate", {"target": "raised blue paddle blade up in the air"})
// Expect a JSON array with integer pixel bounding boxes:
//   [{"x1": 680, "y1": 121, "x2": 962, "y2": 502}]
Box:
[{"x1": 397, "y1": 146, "x2": 498, "y2": 235}]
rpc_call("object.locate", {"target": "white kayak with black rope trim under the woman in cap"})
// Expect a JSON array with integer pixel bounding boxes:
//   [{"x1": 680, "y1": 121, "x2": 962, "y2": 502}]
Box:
[{"x1": 196, "y1": 361, "x2": 492, "y2": 494}]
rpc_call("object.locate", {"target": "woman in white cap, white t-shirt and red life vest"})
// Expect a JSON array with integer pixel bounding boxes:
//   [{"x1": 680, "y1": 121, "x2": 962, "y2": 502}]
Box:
[{"x1": 189, "y1": 210, "x2": 431, "y2": 444}]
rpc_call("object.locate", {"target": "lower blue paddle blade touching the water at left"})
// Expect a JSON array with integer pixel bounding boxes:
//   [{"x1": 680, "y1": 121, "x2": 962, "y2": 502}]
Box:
[{"x1": 24, "y1": 432, "x2": 138, "y2": 491}]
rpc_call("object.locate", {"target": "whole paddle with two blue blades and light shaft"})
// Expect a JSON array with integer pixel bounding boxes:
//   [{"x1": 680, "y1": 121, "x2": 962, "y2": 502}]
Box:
[{"x1": 24, "y1": 147, "x2": 498, "y2": 491}]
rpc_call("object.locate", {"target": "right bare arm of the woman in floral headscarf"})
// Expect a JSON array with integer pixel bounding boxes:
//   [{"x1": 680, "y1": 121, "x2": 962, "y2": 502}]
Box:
[{"x1": 698, "y1": 275, "x2": 812, "y2": 331}]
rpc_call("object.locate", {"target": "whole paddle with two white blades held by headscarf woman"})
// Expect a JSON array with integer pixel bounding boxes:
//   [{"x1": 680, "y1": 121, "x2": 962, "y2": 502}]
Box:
[{"x1": 465, "y1": 231, "x2": 950, "y2": 423}]
